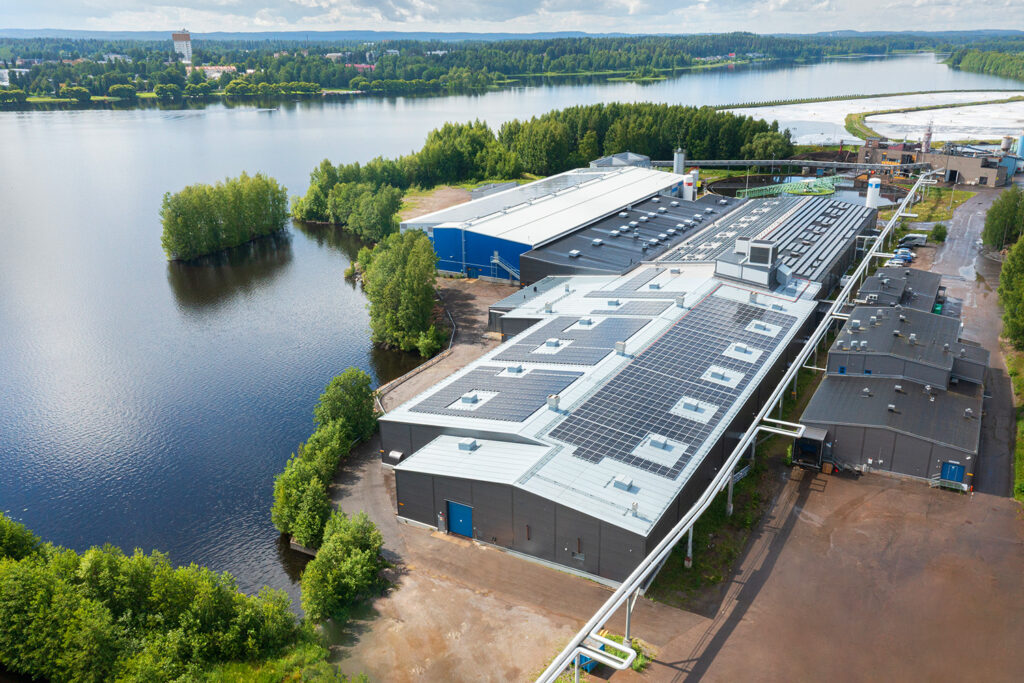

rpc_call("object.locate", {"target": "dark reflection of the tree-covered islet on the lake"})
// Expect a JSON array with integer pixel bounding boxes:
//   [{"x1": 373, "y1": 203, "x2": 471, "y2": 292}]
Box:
[{"x1": 167, "y1": 231, "x2": 292, "y2": 308}]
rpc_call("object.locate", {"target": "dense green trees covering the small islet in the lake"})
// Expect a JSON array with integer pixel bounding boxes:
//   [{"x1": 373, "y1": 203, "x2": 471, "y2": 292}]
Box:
[{"x1": 160, "y1": 173, "x2": 288, "y2": 260}]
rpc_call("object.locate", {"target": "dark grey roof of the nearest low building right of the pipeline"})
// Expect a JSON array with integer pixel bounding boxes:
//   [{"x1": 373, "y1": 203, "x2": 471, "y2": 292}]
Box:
[{"x1": 801, "y1": 376, "x2": 982, "y2": 454}]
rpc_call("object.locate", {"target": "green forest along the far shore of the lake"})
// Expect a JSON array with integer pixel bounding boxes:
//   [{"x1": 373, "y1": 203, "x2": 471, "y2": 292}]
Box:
[{"x1": 8, "y1": 32, "x2": 1024, "y2": 103}]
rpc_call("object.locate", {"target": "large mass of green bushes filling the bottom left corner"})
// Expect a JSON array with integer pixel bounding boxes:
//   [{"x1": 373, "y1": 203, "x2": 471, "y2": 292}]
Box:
[{"x1": 0, "y1": 515, "x2": 299, "y2": 681}]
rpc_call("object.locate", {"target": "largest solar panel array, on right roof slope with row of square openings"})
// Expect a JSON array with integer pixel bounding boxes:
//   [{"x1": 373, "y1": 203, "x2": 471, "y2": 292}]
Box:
[{"x1": 550, "y1": 296, "x2": 798, "y2": 479}]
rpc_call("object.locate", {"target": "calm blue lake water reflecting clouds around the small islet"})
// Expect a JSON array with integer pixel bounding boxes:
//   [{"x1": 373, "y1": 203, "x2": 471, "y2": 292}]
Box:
[{"x1": 0, "y1": 50, "x2": 1019, "y2": 595}]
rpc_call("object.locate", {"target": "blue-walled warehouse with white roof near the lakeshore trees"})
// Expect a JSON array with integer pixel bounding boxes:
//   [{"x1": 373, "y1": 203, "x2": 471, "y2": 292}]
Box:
[{"x1": 401, "y1": 167, "x2": 684, "y2": 283}]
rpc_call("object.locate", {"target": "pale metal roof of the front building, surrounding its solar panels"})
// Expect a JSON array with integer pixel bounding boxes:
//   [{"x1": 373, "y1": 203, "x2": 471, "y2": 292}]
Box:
[{"x1": 382, "y1": 264, "x2": 818, "y2": 536}]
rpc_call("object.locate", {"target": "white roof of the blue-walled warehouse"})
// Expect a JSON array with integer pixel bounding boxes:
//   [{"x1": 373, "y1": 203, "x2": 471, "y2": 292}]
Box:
[{"x1": 402, "y1": 167, "x2": 683, "y2": 248}]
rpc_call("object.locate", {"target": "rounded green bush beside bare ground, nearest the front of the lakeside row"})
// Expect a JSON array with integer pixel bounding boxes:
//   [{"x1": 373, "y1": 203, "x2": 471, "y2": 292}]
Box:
[{"x1": 301, "y1": 511, "x2": 384, "y2": 622}]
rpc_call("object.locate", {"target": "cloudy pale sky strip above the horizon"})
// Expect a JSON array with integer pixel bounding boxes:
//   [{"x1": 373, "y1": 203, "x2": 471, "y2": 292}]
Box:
[{"x1": 0, "y1": 0, "x2": 1024, "y2": 33}]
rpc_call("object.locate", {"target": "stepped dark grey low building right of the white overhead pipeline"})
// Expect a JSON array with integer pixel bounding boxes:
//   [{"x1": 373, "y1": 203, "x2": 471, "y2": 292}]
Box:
[{"x1": 794, "y1": 268, "x2": 989, "y2": 490}]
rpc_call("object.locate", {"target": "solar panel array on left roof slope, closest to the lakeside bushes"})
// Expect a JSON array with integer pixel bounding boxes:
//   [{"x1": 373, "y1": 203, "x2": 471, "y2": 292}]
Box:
[{"x1": 410, "y1": 366, "x2": 583, "y2": 422}]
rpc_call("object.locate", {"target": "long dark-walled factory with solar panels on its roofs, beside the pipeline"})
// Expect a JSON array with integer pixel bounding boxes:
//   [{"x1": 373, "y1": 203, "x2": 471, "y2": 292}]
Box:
[{"x1": 380, "y1": 184, "x2": 876, "y2": 581}]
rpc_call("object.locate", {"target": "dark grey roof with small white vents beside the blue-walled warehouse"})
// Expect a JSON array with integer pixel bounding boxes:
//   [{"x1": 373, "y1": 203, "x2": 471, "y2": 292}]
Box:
[{"x1": 519, "y1": 197, "x2": 738, "y2": 274}]
